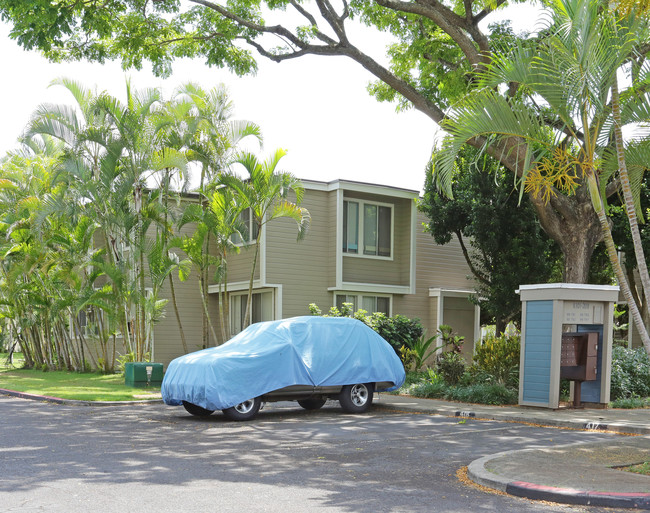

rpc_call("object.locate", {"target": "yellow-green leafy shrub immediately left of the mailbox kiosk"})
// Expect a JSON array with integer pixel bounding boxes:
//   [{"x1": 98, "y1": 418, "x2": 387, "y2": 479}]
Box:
[{"x1": 474, "y1": 334, "x2": 521, "y2": 386}]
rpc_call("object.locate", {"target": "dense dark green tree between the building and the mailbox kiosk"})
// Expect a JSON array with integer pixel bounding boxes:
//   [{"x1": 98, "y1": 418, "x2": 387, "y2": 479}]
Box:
[{"x1": 419, "y1": 148, "x2": 561, "y2": 332}]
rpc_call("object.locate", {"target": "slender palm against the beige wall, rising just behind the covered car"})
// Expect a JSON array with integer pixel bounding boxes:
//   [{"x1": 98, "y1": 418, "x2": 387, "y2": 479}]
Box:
[{"x1": 219, "y1": 149, "x2": 311, "y2": 327}]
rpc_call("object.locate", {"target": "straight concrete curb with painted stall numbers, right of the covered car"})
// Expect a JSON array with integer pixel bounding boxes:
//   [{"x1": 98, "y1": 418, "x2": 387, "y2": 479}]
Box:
[{"x1": 375, "y1": 402, "x2": 650, "y2": 435}]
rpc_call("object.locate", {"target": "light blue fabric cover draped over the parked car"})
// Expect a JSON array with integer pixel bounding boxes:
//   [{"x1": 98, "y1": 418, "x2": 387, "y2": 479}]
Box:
[{"x1": 161, "y1": 317, "x2": 405, "y2": 410}]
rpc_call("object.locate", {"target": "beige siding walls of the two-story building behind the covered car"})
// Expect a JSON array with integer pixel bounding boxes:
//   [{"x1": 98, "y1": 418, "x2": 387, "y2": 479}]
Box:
[{"x1": 155, "y1": 183, "x2": 475, "y2": 364}]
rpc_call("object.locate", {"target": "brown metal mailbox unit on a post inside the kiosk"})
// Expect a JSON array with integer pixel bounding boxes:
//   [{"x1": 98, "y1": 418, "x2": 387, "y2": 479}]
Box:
[{"x1": 560, "y1": 332, "x2": 598, "y2": 408}]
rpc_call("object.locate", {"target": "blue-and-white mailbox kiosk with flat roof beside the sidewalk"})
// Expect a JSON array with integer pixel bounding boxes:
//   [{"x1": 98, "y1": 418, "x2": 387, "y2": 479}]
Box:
[{"x1": 518, "y1": 283, "x2": 619, "y2": 409}]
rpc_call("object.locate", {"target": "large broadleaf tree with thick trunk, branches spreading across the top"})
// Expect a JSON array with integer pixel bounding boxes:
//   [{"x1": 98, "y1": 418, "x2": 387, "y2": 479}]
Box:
[{"x1": 0, "y1": 0, "x2": 632, "y2": 282}]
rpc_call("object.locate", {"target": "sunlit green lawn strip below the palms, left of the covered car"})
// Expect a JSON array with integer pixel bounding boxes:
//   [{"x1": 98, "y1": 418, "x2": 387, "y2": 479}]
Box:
[{"x1": 0, "y1": 353, "x2": 160, "y2": 401}]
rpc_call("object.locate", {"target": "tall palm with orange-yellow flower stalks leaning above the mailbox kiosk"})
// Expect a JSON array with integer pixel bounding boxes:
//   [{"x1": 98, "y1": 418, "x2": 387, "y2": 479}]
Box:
[{"x1": 436, "y1": 0, "x2": 650, "y2": 352}]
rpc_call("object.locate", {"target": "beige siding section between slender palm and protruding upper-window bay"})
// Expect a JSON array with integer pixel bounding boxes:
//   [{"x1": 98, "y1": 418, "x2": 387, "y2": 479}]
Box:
[{"x1": 266, "y1": 190, "x2": 336, "y2": 318}]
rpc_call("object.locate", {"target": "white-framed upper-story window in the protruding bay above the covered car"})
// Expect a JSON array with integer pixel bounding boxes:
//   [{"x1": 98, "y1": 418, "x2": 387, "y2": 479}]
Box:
[{"x1": 343, "y1": 200, "x2": 393, "y2": 257}]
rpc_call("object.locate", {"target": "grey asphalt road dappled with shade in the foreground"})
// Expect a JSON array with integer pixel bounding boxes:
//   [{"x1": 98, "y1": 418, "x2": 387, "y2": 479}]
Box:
[{"x1": 0, "y1": 397, "x2": 632, "y2": 513}]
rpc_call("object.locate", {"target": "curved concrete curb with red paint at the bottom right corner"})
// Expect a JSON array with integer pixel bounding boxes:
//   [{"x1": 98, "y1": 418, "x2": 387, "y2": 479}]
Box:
[{"x1": 467, "y1": 444, "x2": 650, "y2": 510}]
